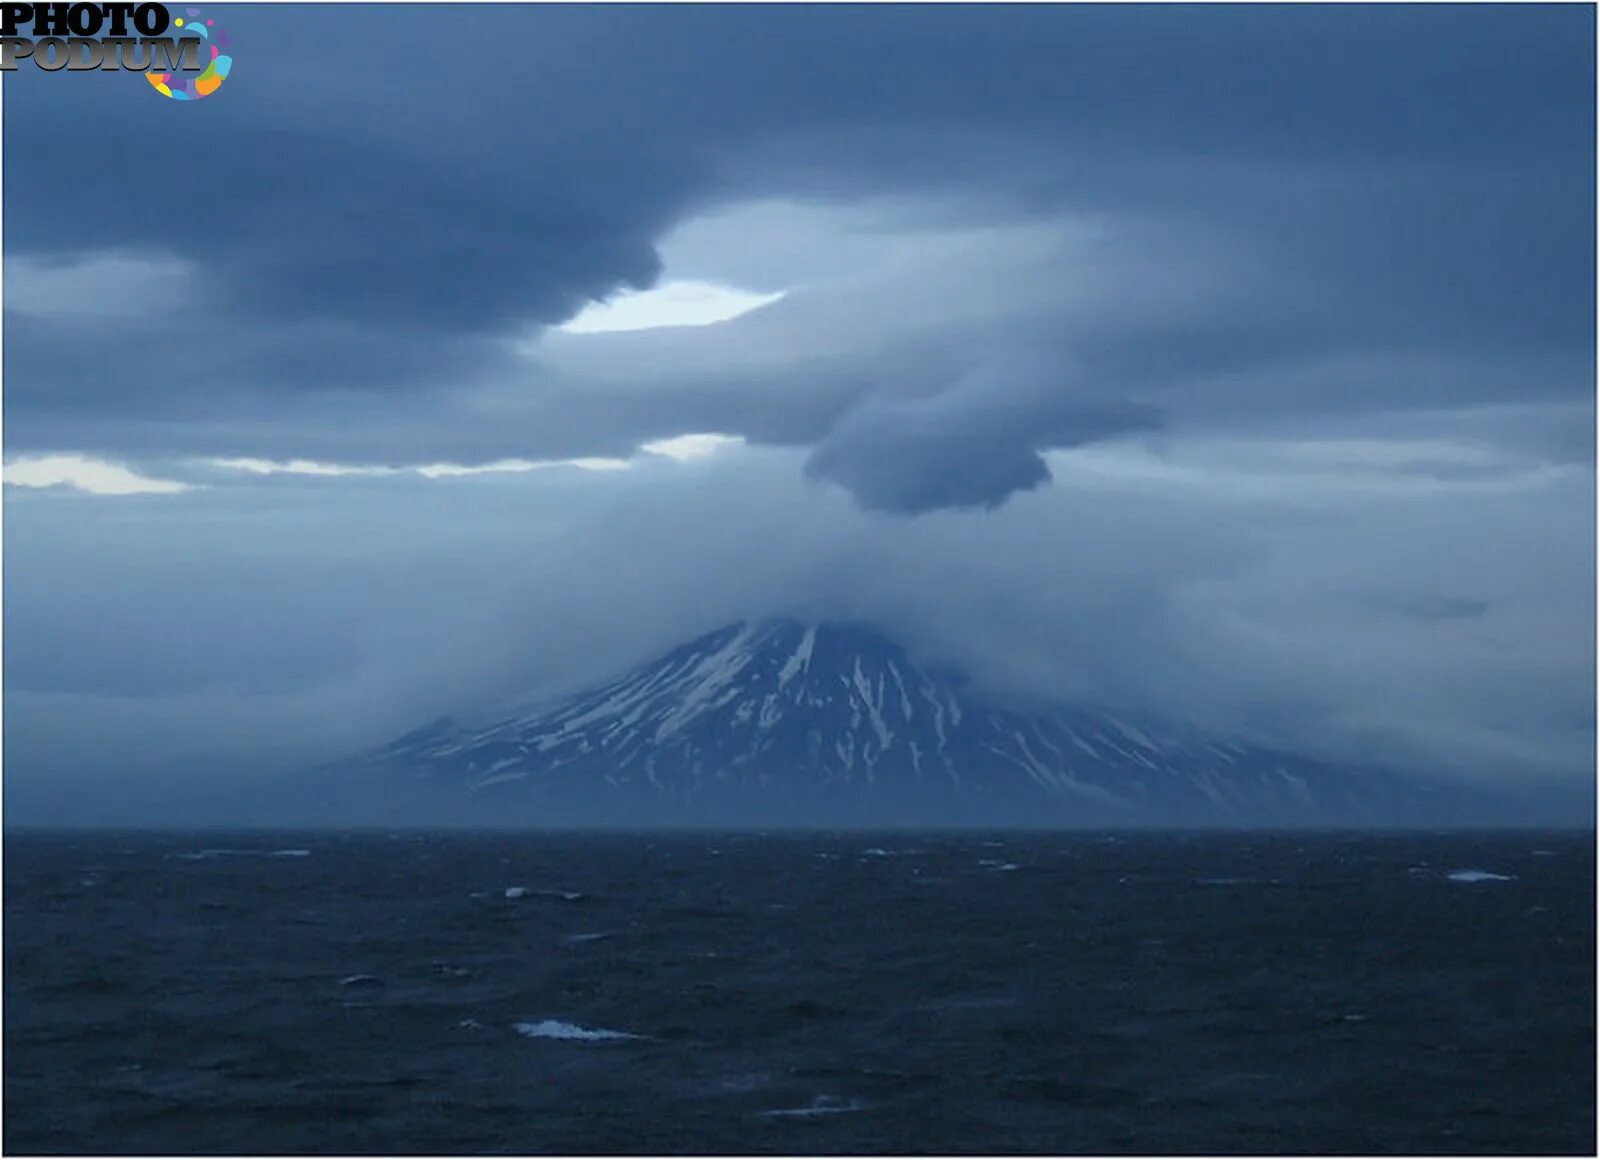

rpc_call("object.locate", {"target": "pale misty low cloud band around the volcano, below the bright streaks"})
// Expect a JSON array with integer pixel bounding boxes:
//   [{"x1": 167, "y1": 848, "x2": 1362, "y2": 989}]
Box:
[{"x1": 6, "y1": 442, "x2": 1594, "y2": 825}]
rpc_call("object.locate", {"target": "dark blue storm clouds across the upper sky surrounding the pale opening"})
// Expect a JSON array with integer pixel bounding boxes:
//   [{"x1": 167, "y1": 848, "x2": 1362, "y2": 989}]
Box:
[{"x1": 6, "y1": 6, "x2": 1594, "y2": 510}]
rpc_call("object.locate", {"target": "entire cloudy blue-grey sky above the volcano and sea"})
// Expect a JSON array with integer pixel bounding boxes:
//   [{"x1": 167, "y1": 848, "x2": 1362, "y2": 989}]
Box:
[{"x1": 3, "y1": 5, "x2": 1595, "y2": 822}]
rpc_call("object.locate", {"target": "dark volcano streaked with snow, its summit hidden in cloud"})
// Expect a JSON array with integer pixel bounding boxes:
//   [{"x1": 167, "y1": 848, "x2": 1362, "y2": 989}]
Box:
[{"x1": 344, "y1": 621, "x2": 1465, "y2": 824}]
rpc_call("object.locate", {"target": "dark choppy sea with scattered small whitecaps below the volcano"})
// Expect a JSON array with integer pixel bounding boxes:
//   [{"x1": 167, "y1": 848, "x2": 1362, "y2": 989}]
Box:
[{"x1": 3, "y1": 834, "x2": 1595, "y2": 1154}]
